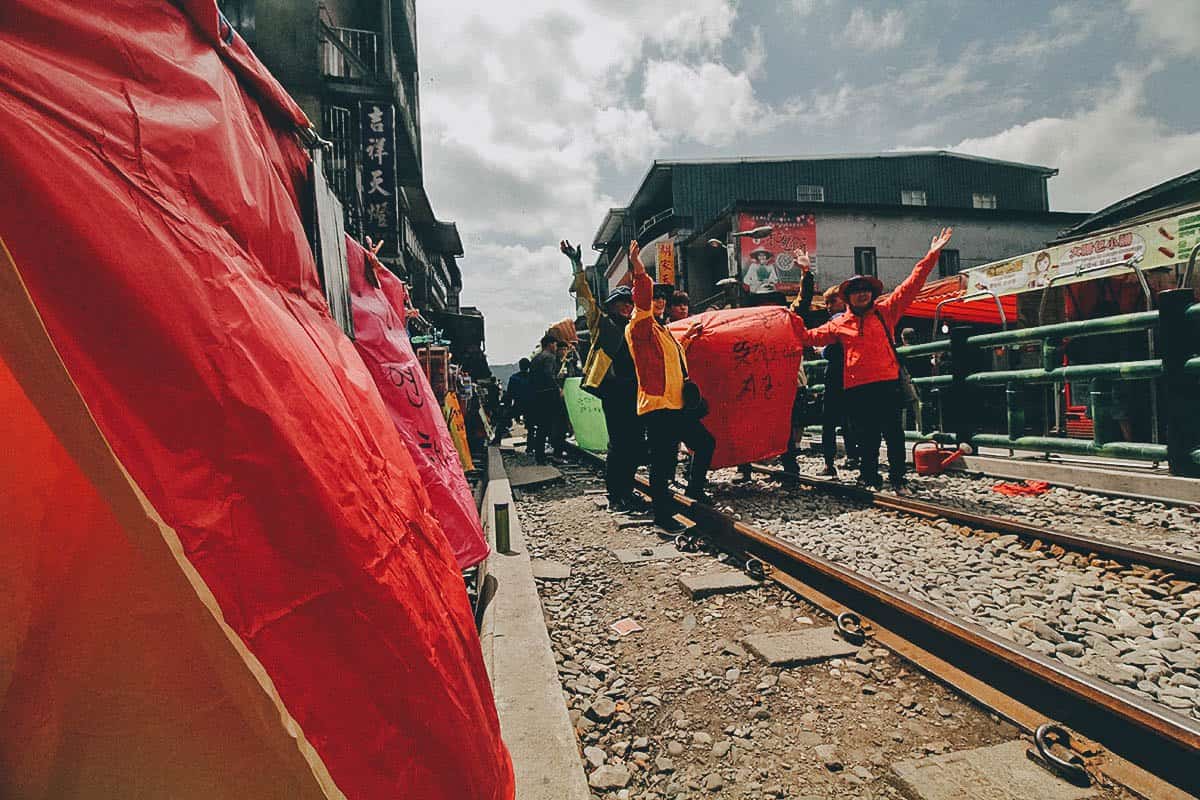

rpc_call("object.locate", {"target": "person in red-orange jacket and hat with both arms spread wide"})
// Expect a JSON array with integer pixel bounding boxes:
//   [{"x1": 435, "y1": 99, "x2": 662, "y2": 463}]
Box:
[{"x1": 800, "y1": 228, "x2": 954, "y2": 491}]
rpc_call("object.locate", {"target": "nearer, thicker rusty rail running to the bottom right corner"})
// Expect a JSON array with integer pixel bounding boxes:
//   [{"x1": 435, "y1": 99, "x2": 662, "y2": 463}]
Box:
[{"x1": 566, "y1": 451, "x2": 1200, "y2": 798}]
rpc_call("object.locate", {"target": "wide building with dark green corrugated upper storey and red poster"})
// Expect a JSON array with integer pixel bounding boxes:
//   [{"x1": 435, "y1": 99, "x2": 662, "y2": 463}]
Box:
[{"x1": 592, "y1": 151, "x2": 1086, "y2": 307}]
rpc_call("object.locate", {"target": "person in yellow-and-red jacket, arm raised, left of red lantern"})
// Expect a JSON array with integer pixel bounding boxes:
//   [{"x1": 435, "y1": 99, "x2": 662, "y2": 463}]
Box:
[{"x1": 625, "y1": 240, "x2": 716, "y2": 535}]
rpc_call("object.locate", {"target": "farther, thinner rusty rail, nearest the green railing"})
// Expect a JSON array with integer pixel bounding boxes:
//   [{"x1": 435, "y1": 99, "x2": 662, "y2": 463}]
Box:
[{"x1": 754, "y1": 464, "x2": 1200, "y2": 581}]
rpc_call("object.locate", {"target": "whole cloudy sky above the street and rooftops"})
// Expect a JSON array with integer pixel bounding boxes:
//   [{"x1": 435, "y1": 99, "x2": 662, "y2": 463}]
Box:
[{"x1": 416, "y1": 0, "x2": 1200, "y2": 363}]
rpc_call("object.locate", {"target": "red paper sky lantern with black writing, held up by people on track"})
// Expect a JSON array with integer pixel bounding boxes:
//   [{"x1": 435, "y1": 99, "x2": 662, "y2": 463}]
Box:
[{"x1": 670, "y1": 306, "x2": 803, "y2": 469}]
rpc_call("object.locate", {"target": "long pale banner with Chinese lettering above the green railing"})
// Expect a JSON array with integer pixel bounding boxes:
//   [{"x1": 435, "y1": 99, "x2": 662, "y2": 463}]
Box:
[{"x1": 964, "y1": 211, "x2": 1200, "y2": 295}]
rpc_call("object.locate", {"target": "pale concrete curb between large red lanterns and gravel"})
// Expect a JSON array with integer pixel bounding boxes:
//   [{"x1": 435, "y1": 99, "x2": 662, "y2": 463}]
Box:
[{"x1": 480, "y1": 447, "x2": 592, "y2": 800}]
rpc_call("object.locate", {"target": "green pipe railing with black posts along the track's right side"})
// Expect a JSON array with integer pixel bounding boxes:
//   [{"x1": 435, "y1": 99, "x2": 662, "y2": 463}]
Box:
[{"x1": 804, "y1": 298, "x2": 1200, "y2": 477}]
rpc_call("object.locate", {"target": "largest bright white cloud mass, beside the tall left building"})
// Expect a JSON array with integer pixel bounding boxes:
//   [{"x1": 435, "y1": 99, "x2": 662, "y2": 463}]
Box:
[{"x1": 418, "y1": 0, "x2": 754, "y2": 361}]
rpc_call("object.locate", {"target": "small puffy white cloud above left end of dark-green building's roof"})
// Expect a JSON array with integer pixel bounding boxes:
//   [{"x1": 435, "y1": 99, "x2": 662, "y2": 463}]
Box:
[{"x1": 642, "y1": 61, "x2": 774, "y2": 145}]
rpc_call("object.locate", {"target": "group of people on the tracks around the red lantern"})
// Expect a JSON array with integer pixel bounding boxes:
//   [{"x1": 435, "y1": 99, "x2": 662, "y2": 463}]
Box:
[{"x1": 508, "y1": 228, "x2": 953, "y2": 535}]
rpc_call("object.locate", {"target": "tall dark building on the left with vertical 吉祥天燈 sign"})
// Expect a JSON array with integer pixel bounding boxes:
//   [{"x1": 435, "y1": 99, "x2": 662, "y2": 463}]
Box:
[{"x1": 218, "y1": 0, "x2": 487, "y2": 377}]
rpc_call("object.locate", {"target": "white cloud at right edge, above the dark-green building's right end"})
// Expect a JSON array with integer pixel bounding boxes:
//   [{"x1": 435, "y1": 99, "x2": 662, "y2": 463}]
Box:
[{"x1": 952, "y1": 67, "x2": 1200, "y2": 211}]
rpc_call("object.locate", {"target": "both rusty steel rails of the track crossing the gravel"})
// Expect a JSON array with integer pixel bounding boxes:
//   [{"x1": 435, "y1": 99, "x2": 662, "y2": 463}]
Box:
[{"x1": 564, "y1": 443, "x2": 1200, "y2": 798}]
